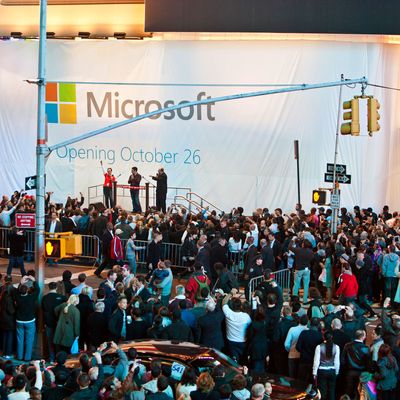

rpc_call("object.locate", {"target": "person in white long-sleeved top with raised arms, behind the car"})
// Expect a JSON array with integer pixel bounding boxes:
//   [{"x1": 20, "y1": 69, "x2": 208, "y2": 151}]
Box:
[{"x1": 222, "y1": 289, "x2": 251, "y2": 361}]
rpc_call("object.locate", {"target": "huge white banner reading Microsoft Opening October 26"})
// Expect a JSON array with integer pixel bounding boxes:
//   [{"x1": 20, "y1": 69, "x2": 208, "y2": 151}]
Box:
[{"x1": 0, "y1": 41, "x2": 400, "y2": 213}]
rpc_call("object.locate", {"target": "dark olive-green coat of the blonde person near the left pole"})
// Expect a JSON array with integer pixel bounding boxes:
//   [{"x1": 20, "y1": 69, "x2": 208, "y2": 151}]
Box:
[{"x1": 54, "y1": 303, "x2": 80, "y2": 347}]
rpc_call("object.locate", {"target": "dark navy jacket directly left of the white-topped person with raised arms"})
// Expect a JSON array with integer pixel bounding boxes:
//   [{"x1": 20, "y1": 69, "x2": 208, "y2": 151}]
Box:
[{"x1": 197, "y1": 310, "x2": 225, "y2": 350}]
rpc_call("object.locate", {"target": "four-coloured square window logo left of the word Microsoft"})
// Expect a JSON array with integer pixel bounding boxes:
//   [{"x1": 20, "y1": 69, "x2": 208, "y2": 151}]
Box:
[{"x1": 46, "y1": 82, "x2": 76, "y2": 124}]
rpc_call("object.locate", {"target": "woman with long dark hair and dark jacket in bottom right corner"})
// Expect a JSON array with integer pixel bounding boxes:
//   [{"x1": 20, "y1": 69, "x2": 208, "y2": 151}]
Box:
[{"x1": 375, "y1": 344, "x2": 399, "y2": 400}]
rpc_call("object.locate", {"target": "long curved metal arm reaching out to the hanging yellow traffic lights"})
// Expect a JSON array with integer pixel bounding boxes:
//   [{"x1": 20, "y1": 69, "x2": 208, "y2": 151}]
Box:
[{"x1": 49, "y1": 77, "x2": 368, "y2": 152}]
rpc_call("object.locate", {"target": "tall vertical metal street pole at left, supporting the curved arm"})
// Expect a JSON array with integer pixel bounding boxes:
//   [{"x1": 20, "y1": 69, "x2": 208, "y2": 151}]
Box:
[{"x1": 35, "y1": 0, "x2": 48, "y2": 356}]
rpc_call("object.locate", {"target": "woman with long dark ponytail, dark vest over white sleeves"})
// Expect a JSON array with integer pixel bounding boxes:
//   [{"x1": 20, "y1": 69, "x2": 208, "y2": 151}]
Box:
[{"x1": 313, "y1": 332, "x2": 340, "y2": 400}]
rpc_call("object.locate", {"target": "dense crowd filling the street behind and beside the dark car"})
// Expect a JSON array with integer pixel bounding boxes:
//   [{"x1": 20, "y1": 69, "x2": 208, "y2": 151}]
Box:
[{"x1": 0, "y1": 188, "x2": 400, "y2": 400}]
